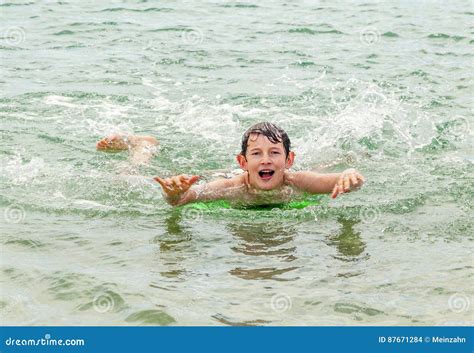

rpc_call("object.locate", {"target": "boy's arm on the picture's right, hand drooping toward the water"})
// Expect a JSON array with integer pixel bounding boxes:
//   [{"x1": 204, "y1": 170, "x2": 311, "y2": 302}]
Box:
[{"x1": 285, "y1": 169, "x2": 365, "y2": 198}]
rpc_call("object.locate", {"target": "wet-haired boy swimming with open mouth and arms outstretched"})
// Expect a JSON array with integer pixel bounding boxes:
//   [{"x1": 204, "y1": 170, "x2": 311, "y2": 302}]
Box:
[{"x1": 98, "y1": 122, "x2": 364, "y2": 206}]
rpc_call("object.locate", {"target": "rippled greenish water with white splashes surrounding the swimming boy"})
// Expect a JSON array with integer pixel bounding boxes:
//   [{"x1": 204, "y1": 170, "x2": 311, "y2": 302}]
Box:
[{"x1": 0, "y1": 0, "x2": 474, "y2": 325}]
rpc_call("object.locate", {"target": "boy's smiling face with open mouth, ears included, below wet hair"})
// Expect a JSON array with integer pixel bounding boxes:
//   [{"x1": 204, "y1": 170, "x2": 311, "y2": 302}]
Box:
[{"x1": 237, "y1": 134, "x2": 295, "y2": 190}]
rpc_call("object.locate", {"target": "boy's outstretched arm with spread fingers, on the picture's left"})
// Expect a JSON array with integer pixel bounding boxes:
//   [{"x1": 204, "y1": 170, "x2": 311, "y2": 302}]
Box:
[{"x1": 155, "y1": 175, "x2": 242, "y2": 206}]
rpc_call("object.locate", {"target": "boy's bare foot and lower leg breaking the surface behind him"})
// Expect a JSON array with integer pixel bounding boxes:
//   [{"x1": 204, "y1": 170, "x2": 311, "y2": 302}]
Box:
[{"x1": 96, "y1": 135, "x2": 158, "y2": 165}]
